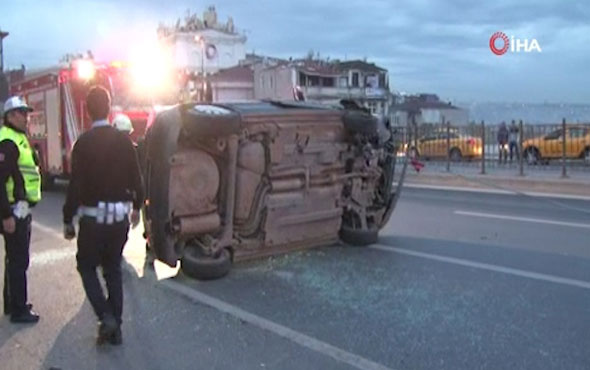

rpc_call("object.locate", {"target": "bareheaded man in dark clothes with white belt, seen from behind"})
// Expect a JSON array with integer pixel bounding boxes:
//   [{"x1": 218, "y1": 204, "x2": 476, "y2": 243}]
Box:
[{"x1": 63, "y1": 87, "x2": 143, "y2": 345}]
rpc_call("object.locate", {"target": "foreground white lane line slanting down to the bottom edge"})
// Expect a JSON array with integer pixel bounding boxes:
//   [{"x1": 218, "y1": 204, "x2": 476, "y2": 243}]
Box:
[{"x1": 160, "y1": 280, "x2": 396, "y2": 370}]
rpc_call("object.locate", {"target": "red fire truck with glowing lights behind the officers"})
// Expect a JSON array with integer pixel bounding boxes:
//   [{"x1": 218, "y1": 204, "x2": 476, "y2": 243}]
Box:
[{"x1": 10, "y1": 58, "x2": 150, "y2": 187}]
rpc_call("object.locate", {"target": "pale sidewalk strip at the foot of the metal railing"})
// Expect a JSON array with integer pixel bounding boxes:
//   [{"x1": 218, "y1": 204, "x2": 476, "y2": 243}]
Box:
[{"x1": 405, "y1": 162, "x2": 590, "y2": 197}]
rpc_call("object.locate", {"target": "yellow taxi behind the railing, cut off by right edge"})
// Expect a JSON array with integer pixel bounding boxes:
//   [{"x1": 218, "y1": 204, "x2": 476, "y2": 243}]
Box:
[{"x1": 522, "y1": 125, "x2": 590, "y2": 164}]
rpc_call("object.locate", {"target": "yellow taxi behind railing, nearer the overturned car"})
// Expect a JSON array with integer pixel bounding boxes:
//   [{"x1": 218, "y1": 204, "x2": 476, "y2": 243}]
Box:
[{"x1": 410, "y1": 130, "x2": 482, "y2": 162}]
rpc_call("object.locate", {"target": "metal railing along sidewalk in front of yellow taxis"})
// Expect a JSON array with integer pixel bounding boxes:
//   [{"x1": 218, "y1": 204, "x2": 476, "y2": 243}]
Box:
[{"x1": 396, "y1": 118, "x2": 590, "y2": 178}]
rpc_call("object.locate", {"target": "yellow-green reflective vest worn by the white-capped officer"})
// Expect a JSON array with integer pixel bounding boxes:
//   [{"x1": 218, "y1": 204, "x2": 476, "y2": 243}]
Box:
[{"x1": 0, "y1": 126, "x2": 41, "y2": 203}]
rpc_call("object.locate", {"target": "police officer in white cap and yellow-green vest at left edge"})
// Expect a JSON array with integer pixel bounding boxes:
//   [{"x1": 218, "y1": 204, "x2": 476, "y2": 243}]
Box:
[{"x1": 0, "y1": 97, "x2": 41, "y2": 323}]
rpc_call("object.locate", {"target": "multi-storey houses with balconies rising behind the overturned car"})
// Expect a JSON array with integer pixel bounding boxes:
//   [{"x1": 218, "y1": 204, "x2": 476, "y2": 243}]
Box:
[{"x1": 254, "y1": 58, "x2": 391, "y2": 115}]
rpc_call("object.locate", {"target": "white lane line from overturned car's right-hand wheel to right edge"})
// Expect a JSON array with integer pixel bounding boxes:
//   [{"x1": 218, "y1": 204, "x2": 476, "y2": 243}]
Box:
[{"x1": 370, "y1": 244, "x2": 590, "y2": 289}]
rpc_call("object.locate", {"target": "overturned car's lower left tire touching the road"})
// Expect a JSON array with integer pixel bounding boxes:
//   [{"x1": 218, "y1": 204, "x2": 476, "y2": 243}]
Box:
[{"x1": 180, "y1": 246, "x2": 232, "y2": 280}]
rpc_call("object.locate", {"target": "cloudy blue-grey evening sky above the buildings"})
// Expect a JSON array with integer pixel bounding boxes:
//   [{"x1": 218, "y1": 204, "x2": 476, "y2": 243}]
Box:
[{"x1": 0, "y1": 0, "x2": 590, "y2": 104}]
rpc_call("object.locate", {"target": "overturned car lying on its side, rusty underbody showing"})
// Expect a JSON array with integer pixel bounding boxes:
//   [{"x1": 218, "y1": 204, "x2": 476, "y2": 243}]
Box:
[{"x1": 142, "y1": 101, "x2": 405, "y2": 279}]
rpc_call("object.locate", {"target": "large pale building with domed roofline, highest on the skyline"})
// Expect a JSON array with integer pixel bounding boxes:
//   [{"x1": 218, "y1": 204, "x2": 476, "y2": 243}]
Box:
[{"x1": 158, "y1": 6, "x2": 247, "y2": 74}]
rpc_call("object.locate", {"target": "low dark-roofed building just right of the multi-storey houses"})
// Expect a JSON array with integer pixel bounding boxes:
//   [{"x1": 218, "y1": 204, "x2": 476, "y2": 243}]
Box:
[{"x1": 390, "y1": 94, "x2": 469, "y2": 126}]
